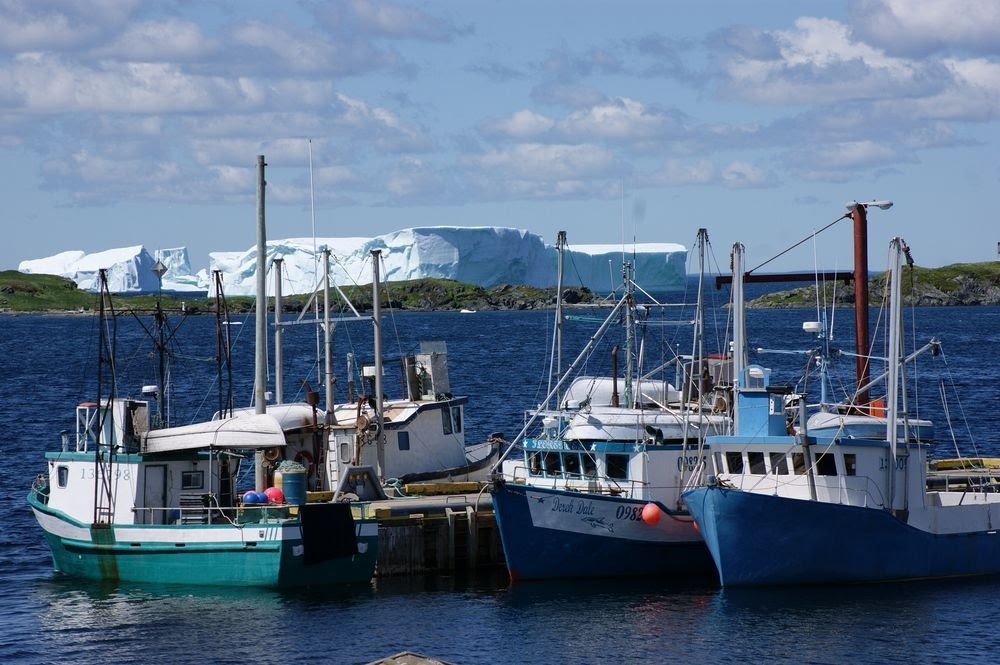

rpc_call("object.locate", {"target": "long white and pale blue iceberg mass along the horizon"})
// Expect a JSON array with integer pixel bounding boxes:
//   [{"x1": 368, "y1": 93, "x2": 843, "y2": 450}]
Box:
[{"x1": 18, "y1": 226, "x2": 687, "y2": 296}]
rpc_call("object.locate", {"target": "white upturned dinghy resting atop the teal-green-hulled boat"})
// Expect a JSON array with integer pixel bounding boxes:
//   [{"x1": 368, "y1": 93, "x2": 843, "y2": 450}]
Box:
[{"x1": 142, "y1": 413, "x2": 285, "y2": 454}]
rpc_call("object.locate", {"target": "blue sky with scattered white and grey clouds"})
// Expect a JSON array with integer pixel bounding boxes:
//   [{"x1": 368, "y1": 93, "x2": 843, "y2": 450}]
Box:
[{"x1": 0, "y1": 0, "x2": 1000, "y2": 269}]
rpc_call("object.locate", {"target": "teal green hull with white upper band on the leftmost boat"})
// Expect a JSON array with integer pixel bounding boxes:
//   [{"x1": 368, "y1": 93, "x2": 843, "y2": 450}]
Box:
[{"x1": 28, "y1": 495, "x2": 378, "y2": 587}]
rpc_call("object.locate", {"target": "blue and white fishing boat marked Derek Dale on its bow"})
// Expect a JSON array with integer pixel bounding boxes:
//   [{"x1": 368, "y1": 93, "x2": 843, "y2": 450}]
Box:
[{"x1": 491, "y1": 229, "x2": 730, "y2": 580}]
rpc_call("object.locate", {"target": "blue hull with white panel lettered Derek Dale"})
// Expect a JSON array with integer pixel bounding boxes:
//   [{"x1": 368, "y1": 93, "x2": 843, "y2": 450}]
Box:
[{"x1": 492, "y1": 481, "x2": 715, "y2": 580}]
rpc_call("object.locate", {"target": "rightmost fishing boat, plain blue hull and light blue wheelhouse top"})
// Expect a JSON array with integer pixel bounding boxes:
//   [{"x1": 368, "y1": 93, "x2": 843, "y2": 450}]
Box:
[{"x1": 684, "y1": 205, "x2": 1000, "y2": 586}]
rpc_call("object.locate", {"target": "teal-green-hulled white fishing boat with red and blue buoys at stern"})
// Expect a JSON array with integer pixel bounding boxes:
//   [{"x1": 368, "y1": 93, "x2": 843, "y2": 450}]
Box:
[{"x1": 27, "y1": 157, "x2": 378, "y2": 587}]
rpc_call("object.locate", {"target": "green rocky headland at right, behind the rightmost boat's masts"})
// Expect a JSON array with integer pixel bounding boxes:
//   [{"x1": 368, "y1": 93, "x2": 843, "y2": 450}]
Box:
[{"x1": 748, "y1": 261, "x2": 1000, "y2": 308}]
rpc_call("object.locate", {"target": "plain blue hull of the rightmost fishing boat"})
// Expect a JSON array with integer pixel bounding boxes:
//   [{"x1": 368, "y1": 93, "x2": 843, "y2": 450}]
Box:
[{"x1": 684, "y1": 487, "x2": 1000, "y2": 586}]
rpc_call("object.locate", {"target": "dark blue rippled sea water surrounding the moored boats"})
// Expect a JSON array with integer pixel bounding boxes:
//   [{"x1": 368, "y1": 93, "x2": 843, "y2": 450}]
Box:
[{"x1": 0, "y1": 302, "x2": 1000, "y2": 665}]
